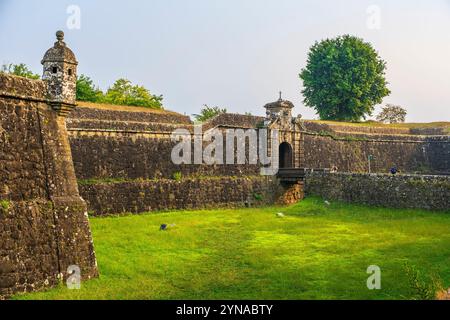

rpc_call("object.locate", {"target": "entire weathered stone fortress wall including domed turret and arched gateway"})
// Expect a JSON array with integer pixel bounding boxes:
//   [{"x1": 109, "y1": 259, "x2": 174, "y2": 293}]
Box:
[{"x1": 0, "y1": 32, "x2": 450, "y2": 298}]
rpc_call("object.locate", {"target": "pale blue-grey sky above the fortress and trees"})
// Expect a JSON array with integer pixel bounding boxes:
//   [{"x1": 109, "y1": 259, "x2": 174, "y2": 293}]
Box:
[{"x1": 0, "y1": 0, "x2": 450, "y2": 122}]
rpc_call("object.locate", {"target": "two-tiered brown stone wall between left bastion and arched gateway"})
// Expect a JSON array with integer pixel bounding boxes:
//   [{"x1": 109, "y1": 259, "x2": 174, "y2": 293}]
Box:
[{"x1": 67, "y1": 103, "x2": 270, "y2": 215}]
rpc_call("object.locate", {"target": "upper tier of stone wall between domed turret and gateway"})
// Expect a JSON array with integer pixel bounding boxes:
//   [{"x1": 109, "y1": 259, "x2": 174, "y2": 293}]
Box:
[{"x1": 67, "y1": 109, "x2": 260, "y2": 180}]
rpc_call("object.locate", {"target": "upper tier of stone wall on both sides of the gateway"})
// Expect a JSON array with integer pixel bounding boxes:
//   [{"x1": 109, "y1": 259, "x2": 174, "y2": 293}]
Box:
[{"x1": 67, "y1": 107, "x2": 450, "y2": 184}]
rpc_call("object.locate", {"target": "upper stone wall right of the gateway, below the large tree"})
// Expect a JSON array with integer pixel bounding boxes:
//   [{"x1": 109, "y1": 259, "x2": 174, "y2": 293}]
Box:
[{"x1": 300, "y1": 124, "x2": 450, "y2": 174}]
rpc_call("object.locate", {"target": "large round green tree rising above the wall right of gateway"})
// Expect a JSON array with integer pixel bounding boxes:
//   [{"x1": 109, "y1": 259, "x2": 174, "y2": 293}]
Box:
[{"x1": 300, "y1": 35, "x2": 390, "y2": 121}]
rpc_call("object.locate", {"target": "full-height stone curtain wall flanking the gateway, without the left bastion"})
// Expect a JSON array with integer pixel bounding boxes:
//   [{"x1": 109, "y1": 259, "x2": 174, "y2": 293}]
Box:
[{"x1": 67, "y1": 102, "x2": 450, "y2": 215}]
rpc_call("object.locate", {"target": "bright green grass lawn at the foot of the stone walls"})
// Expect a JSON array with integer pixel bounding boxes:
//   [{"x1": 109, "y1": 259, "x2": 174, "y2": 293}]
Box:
[{"x1": 15, "y1": 198, "x2": 450, "y2": 299}]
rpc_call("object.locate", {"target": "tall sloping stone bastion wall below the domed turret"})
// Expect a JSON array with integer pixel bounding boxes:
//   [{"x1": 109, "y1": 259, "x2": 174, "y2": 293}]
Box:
[{"x1": 0, "y1": 74, "x2": 97, "y2": 299}]
